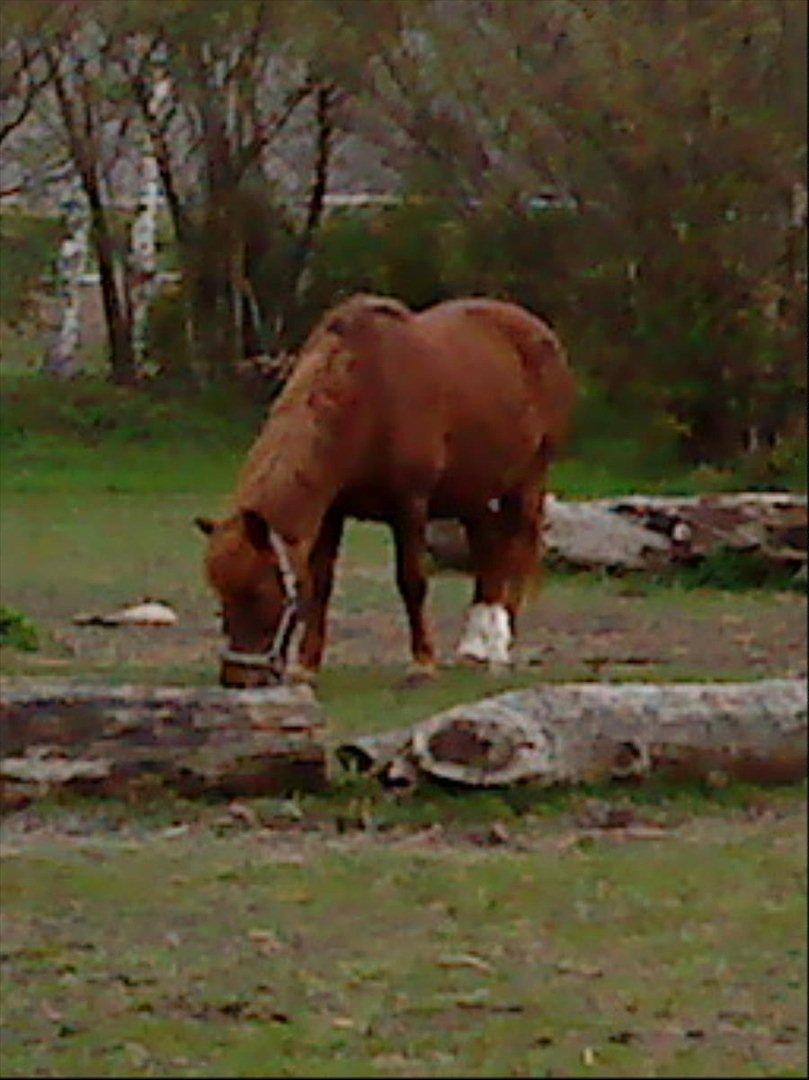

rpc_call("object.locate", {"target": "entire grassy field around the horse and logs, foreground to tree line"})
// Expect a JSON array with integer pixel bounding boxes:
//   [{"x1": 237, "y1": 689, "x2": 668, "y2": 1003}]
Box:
[{"x1": 0, "y1": 369, "x2": 806, "y2": 1077}]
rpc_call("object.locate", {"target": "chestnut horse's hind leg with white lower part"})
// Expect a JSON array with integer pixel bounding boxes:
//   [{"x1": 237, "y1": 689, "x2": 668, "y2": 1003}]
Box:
[{"x1": 458, "y1": 491, "x2": 540, "y2": 665}]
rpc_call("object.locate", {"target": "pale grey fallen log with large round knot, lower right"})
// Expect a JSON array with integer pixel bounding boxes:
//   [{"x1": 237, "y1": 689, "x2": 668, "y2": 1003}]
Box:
[{"x1": 337, "y1": 679, "x2": 807, "y2": 787}]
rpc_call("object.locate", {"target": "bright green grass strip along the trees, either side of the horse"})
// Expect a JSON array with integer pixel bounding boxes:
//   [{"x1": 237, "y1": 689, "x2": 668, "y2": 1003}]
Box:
[{"x1": 0, "y1": 375, "x2": 806, "y2": 499}]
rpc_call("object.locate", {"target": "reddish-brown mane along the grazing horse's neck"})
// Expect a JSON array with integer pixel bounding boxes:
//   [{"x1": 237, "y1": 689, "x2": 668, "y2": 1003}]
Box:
[{"x1": 235, "y1": 294, "x2": 413, "y2": 505}]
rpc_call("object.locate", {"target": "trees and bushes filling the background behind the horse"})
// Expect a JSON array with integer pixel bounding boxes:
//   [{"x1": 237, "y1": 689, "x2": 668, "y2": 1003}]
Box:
[{"x1": 0, "y1": 0, "x2": 807, "y2": 470}]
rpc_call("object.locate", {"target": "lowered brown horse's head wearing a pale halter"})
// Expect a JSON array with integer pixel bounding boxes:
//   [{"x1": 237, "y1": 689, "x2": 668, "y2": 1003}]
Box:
[{"x1": 195, "y1": 510, "x2": 298, "y2": 688}]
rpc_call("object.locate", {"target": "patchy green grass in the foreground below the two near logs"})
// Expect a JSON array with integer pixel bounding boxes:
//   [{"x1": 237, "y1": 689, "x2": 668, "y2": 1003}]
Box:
[{"x1": 2, "y1": 809, "x2": 805, "y2": 1077}]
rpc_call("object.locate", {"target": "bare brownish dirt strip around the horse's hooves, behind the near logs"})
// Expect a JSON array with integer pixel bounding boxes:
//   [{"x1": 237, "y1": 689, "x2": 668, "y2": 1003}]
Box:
[{"x1": 17, "y1": 566, "x2": 807, "y2": 678}]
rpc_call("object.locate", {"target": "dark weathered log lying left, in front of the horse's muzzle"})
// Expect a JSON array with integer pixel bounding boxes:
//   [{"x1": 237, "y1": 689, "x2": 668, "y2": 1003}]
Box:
[{"x1": 0, "y1": 680, "x2": 327, "y2": 807}]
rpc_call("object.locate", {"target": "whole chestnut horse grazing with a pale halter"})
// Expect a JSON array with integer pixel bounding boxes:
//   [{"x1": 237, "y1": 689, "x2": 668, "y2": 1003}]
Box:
[{"x1": 197, "y1": 295, "x2": 572, "y2": 687}]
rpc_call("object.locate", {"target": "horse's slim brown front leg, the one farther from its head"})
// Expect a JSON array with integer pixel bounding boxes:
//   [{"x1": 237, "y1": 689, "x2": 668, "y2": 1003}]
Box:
[{"x1": 391, "y1": 499, "x2": 435, "y2": 677}]
